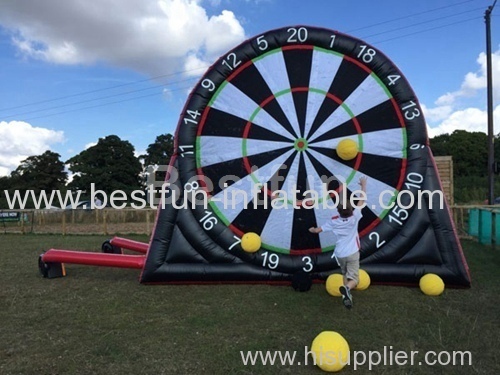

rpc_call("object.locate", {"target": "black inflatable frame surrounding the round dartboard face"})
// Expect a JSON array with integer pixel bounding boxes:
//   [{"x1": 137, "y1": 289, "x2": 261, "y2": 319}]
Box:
[{"x1": 141, "y1": 26, "x2": 470, "y2": 286}]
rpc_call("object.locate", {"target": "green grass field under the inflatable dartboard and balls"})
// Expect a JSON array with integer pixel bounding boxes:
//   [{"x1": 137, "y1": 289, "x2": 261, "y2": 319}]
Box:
[{"x1": 0, "y1": 234, "x2": 500, "y2": 375}]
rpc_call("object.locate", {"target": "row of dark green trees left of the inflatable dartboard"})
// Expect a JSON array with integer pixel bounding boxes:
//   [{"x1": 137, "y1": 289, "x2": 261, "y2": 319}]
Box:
[{"x1": 0, "y1": 134, "x2": 174, "y2": 209}]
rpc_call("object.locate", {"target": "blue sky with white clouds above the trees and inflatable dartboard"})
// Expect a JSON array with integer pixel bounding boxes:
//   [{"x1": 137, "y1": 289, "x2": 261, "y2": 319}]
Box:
[{"x1": 0, "y1": 0, "x2": 500, "y2": 176}]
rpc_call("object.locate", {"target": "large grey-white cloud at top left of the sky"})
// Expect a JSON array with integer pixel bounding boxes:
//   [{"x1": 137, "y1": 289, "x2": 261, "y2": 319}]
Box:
[{"x1": 0, "y1": 0, "x2": 245, "y2": 76}]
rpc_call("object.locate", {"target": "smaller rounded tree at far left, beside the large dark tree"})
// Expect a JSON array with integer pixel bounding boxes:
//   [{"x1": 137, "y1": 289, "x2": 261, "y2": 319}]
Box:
[{"x1": 10, "y1": 151, "x2": 68, "y2": 192}]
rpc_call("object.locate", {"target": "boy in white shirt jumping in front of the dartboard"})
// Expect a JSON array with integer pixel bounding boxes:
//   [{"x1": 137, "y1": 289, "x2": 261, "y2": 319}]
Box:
[{"x1": 309, "y1": 177, "x2": 366, "y2": 309}]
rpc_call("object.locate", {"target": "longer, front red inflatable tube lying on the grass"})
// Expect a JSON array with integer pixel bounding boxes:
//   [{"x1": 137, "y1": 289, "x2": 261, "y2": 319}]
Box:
[{"x1": 42, "y1": 249, "x2": 146, "y2": 269}]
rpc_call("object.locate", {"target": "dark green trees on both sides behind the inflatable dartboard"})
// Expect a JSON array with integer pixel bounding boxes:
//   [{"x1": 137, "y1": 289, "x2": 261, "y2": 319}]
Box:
[{"x1": 0, "y1": 130, "x2": 500, "y2": 208}]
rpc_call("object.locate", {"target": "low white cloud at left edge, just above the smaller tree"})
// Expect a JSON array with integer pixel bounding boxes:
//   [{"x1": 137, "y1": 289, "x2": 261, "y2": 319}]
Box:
[{"x1": 0, "y1": 121, "x2": 64, "y2": 176}]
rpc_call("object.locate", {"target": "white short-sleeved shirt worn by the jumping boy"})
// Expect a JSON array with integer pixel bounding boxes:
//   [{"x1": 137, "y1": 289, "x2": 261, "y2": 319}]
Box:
[{"x1": 321, "y1": 208, "x2": 363, "y2": 258}]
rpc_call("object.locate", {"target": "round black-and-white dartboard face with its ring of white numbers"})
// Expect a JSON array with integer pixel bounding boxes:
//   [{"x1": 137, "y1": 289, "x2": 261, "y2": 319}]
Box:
[{"x1": 143, "y1": 26, "x2": 470, "y2": 288}]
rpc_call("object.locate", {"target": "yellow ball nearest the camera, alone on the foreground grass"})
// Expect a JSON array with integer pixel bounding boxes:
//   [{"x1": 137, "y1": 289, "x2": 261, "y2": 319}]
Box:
[{"x1": 311, "y1": 331, "x2": 349, "y2": 372}]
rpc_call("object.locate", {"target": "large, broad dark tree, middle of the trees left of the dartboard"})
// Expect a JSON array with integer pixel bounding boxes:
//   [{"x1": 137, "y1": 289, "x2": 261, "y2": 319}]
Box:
[{"x1": 67, "y1": 135, "x2": 141, "y2": 196}]
